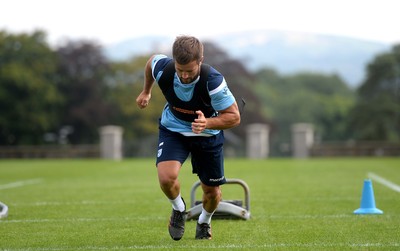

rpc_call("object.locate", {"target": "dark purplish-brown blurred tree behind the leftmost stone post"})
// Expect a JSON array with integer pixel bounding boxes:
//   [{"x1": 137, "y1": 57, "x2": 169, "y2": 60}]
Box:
[{"x1": 57, "y1": 41, "x2": 113, "y2": 144}]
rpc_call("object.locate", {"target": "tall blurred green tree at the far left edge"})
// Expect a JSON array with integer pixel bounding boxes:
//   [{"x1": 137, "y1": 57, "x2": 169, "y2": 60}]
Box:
[{"x1": 0, "y1": 31, "x2": 63, "y2": 145}]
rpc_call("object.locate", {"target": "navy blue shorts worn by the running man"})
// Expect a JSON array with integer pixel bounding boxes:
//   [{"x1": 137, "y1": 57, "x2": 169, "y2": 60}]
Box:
[{"x1": 156, "y1": 125, "x2": 226, "y2": 186}]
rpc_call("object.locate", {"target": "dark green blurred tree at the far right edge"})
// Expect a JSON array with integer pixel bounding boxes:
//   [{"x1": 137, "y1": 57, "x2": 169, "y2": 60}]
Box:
[{"x1": 350, "y1": 45, "x2": 400, "y2": 142}]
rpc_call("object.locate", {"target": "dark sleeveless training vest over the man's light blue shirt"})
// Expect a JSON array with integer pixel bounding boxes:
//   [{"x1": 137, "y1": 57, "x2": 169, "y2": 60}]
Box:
[{"x1": 158, "y1": 60, "x2": 216, "y2": 122}]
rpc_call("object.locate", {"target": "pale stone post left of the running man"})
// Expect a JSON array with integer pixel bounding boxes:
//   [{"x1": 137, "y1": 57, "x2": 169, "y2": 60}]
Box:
[{"x1": 100, "y1": 125, "x2": 123, "y2": 160}]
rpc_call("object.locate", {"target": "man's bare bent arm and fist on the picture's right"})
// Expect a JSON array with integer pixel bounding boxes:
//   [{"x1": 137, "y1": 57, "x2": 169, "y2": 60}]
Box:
[{"x1": 192, "y1": 101, "x2": 240, "y2": 133}]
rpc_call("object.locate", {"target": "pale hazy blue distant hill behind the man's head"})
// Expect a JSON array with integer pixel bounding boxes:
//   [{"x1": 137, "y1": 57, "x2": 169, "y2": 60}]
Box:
[{"x1": 105, "y1": 30, "x2": 391, "y2": 87}]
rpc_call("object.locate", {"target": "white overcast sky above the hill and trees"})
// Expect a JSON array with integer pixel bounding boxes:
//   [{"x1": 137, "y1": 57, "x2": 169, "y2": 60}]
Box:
[{"x1": 0, "y1": 0, "x2": 400, "y2": 45}]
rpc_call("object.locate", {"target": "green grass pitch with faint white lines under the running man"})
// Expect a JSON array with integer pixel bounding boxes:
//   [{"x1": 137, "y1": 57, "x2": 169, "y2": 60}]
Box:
[{"x1": 0, "y1": 158, "x2": 400, "y2": 251}]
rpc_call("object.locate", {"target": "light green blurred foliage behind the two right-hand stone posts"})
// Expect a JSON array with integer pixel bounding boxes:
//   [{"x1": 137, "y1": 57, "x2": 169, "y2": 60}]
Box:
[{"x1": 256, "y1": 69, "x2": 354, "y2": 155}]
